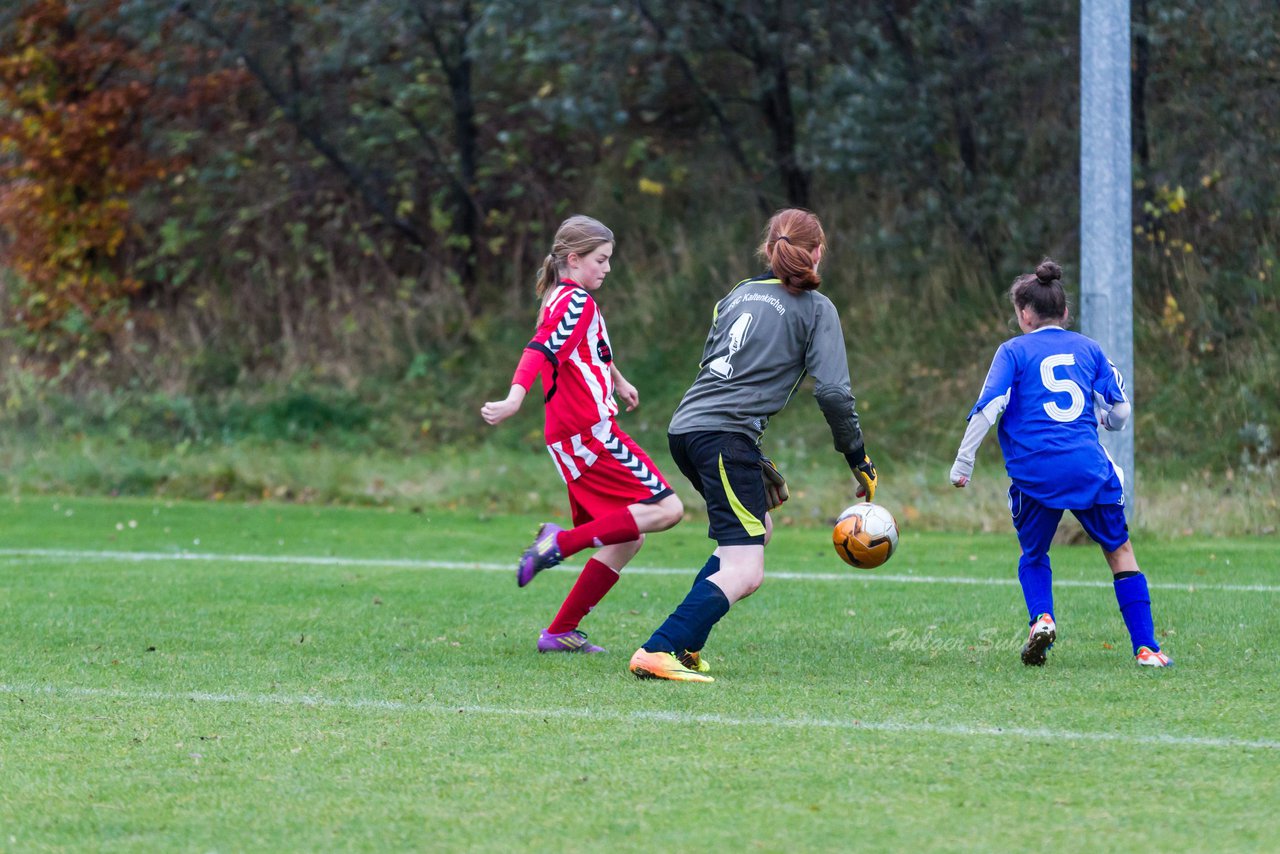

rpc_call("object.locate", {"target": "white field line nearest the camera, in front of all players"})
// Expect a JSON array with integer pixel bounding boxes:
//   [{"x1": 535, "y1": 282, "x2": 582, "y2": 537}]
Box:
[{"x1": 0, "y1": 682, "x2": 1280, "y2": 750}]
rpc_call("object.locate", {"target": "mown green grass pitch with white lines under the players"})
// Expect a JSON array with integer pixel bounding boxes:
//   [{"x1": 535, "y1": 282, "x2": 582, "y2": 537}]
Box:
[{"x1": 0, "y1": 497, "x2": 1280, "y2": 851}]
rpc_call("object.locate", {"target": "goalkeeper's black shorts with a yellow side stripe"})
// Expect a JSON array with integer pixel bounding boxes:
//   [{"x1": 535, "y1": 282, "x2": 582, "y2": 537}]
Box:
[{"x1": 667, "y1": 433, "x2": 769, "y2": 545}]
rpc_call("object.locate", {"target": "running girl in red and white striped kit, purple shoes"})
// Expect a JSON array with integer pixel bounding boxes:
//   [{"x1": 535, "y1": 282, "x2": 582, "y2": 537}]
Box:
[{"x1": 480, "y1": 216, "x2": 685, "y2": 653}]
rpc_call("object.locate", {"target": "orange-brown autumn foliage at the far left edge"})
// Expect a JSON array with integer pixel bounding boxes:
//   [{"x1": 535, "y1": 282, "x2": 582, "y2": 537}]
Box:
[{"x1": 0, "y1": 0, "x2": 240, "y2": 352}]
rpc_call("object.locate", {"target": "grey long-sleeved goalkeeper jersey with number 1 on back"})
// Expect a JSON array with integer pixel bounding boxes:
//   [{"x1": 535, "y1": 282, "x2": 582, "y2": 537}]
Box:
[{"x1": 668, "y1": 274, "x2": 863, "y2": 465}]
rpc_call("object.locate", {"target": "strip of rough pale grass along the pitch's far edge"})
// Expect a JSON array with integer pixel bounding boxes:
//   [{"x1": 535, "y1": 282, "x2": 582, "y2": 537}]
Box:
[{"x1": 0, "y1": 430, "x2": 1280, "y2": 538}]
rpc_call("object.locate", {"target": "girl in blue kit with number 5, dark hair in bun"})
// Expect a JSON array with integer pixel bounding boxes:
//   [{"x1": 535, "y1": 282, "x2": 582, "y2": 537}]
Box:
[{"x1": 951, "y1": 259, "x2": 1172, "y2": 667}]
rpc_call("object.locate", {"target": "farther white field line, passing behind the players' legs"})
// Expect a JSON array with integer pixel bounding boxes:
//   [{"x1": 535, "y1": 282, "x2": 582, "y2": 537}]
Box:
[{"x1": 0, "y1": 548, "x2": 1280, "y2": 593}]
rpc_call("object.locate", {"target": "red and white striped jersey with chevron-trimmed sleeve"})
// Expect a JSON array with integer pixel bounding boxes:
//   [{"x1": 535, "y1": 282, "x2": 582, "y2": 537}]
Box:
[{"x1": 527, "y1": 280, "x2": 618, "y2": 444}]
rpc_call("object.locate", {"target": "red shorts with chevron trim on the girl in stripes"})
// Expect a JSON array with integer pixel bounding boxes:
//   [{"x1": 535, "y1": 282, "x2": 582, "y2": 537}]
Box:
[{"x1": 547, "y1": 419, "x2": 672, "y2": 526}]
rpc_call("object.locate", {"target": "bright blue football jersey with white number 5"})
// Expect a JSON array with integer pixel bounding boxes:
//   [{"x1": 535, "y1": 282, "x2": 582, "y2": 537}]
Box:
[{"x1": 969, "y1": 326, "x2": 1128, "y2": 510}]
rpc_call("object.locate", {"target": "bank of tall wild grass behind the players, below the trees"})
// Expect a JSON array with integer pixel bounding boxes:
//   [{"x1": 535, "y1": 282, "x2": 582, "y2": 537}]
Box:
[{"x1": 0, "y1": 181, "x2": 1280, "y2": 531}]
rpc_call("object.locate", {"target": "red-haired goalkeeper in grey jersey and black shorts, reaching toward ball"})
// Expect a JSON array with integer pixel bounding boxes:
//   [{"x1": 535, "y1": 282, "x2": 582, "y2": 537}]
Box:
[{"x1": 630, "y1": 209, "x2": 876, "y2": 682}]
